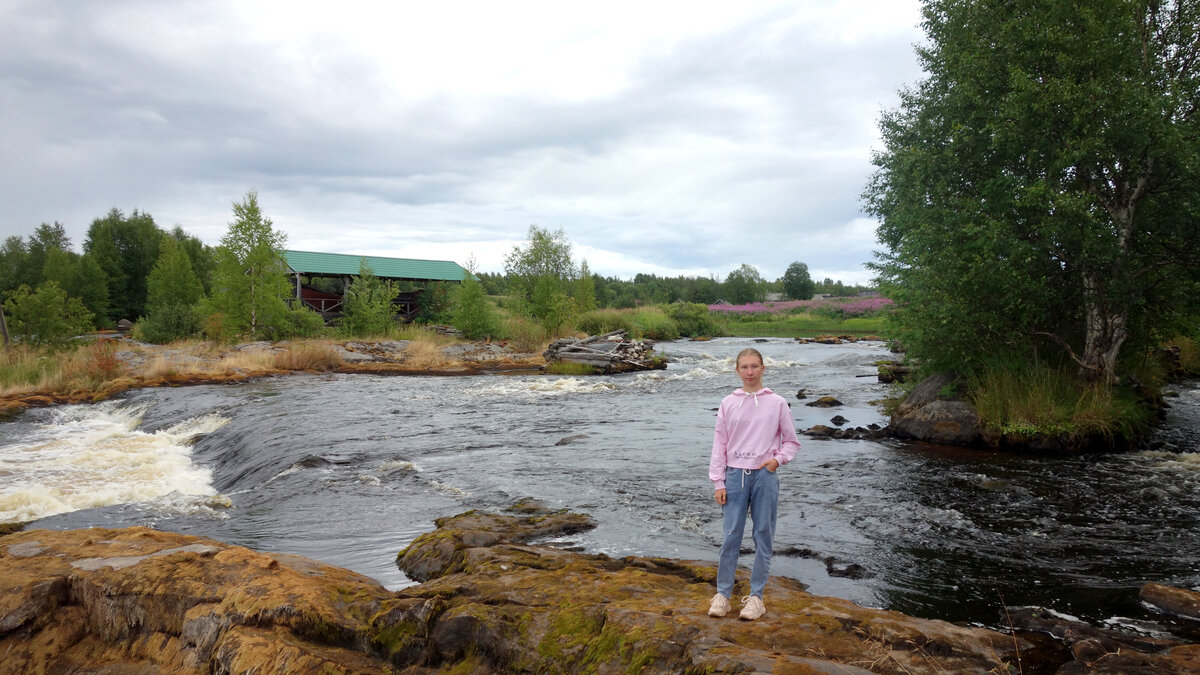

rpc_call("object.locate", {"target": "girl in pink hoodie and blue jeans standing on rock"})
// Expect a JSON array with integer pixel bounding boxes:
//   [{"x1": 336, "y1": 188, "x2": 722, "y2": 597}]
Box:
[{"x1": 708, "y1": 348, "x2": 800, "y2": 621}]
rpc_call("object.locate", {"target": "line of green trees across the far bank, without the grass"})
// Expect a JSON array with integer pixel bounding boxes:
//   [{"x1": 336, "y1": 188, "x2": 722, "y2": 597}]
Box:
[{"x1": 0, "y1": 206, "x2": 862, "y2": 345}]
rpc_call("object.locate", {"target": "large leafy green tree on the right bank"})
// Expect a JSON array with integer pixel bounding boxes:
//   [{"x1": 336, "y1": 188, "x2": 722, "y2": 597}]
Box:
[{"x1": 865, "y1": 0, "x2": 1200, "y2": 382}]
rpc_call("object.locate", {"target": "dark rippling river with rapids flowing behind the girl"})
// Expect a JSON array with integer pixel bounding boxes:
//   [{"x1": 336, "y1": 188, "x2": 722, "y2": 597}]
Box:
[{"x1": 0, "y1": 339, "x2": 1200, "y2": 640}]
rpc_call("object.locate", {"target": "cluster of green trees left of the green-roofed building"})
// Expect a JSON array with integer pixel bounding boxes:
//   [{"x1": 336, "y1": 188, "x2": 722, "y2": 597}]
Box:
[{"x1": 0, "y1": 191, "x2": 322, "y2": 345}]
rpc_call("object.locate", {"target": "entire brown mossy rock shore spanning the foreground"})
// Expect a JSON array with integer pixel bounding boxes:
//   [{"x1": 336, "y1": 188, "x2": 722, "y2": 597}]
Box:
[{"x1": 0, "y1": 502, "x2": 1200, "y2": 675}]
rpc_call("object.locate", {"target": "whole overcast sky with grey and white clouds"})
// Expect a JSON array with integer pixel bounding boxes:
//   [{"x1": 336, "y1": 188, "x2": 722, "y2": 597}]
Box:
[{"x1": 0, "y1": 0, "x2": 922, "y2": 283}]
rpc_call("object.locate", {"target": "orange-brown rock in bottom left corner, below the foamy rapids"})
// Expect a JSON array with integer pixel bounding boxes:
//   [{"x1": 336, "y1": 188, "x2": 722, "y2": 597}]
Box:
[{"x1": 0, "y1": 527, "x2": 391, "y2": 674}]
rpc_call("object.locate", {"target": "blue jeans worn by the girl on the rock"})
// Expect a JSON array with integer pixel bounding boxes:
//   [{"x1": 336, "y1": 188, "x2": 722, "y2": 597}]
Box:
[{"x1": 716, "y1": 468, "x2": 779, "y2": 598}]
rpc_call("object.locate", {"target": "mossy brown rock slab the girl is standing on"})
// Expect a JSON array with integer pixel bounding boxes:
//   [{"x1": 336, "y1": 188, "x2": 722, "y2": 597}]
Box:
[{"x1": 401, "y1": 513, "x2": 1032, "y2": 673}]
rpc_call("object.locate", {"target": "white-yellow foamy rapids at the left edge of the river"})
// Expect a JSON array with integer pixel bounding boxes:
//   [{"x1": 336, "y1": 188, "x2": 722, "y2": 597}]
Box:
[{"x1": 0, "y1": 404, "x2": 228, "y2": 522}]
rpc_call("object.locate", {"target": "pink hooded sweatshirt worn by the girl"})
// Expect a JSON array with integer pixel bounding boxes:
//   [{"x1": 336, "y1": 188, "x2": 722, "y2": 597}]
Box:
[{"x1": 708, "y1": 387, "x2": 800, "y2": 490}]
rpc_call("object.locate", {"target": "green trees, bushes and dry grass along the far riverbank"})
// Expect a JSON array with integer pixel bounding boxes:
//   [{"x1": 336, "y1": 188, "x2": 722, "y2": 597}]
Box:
[{"x1": 0, "y1": 199, "x2": 882, "y2": 396}]
